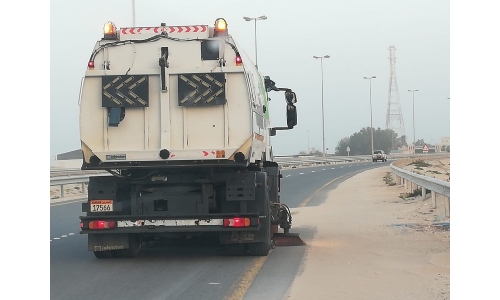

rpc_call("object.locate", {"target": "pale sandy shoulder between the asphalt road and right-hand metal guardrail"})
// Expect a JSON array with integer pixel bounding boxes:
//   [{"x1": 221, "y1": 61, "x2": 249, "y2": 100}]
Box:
[{"x1": 285, "y1": 166, "x2": 450, "y2": 300}]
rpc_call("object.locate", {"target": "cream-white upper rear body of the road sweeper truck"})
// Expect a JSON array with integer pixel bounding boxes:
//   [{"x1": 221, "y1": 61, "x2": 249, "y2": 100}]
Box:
[{"x1": 80, "y1": 20, "x2": 282, "y2": 169}]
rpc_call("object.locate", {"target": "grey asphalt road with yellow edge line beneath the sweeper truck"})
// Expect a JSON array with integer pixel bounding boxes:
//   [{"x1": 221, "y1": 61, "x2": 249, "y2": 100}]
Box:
[{"x1": 50, "y1": 162, "x2": 390, "y2": 300}]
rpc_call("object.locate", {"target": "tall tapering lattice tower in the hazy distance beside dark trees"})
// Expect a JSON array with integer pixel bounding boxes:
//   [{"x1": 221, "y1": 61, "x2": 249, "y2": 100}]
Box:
[{"x1": 385, "y1": 45, "x2": 405, "y2": 149}]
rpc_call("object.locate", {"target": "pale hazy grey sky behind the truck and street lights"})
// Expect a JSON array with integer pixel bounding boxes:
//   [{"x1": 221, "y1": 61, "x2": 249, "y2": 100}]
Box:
[{"x1": 50, "y1": 0, "x2": 450, "y2": 158}]
